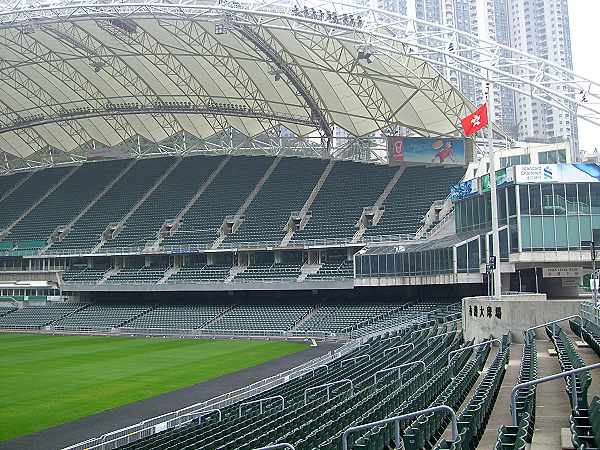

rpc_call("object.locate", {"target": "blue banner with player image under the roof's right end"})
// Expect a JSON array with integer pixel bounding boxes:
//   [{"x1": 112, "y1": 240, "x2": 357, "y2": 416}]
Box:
[{"x1": 387, "y1": 136, "x2": 473, "y2": 166}]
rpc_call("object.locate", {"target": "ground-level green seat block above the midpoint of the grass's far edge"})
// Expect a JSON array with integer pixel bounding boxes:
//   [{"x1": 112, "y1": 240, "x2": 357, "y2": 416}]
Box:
[{"x1": 125, "y1": 305, "x2": 228, "y2": 330}]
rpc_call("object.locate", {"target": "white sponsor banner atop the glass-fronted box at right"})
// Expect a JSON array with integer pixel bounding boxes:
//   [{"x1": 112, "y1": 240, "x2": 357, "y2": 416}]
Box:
[{"x1": 515, "y1": 163, "x2": 600, "y2": 184}]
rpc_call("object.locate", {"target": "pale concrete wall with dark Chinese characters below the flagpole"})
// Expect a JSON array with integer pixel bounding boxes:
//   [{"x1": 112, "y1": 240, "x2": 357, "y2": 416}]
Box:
[{"x1": 463, "y1": 294, "x2": 581, "y2": 342}]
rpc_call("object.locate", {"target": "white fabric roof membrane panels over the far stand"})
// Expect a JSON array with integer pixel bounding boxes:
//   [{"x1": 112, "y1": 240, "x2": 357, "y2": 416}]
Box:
[{"x1": 0, "y1": 3, "x2": 472, "y2": 163}]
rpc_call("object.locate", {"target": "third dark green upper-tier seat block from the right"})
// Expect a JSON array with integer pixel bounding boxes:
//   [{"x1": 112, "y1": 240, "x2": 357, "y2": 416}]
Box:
[{"x1": 224, "y1": 158, "x2": 327, "y2": 244}]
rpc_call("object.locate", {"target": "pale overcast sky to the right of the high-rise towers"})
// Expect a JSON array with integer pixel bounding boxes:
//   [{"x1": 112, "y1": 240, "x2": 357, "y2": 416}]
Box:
[{"x1": 569, "y1": 0, "x2": 600, "y2": 152}]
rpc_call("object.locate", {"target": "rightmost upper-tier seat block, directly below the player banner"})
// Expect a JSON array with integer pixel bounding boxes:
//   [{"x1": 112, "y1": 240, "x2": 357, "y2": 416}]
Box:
[{"x1": 365, "y1": 167, "x2": 465, "y2": 236}]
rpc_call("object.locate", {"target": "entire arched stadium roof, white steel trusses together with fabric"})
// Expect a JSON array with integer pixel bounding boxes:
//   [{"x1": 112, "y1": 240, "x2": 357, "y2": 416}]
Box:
[{"x1": 0, "y1": 0, "x2": 600, "y2": 172}]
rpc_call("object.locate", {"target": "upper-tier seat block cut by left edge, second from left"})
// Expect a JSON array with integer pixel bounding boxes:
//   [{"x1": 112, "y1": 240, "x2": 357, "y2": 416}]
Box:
[{"x1": 0, "y1": 167, "x2": 73, "y2": 234}]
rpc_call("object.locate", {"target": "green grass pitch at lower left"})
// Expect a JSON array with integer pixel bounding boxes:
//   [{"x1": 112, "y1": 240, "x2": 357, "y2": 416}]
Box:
[{"x1": 0, "y1": 334, "x2": 306, "y2": 441}]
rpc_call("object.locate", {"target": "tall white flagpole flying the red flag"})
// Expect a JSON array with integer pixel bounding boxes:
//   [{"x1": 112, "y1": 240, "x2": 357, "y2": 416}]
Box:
[{"x1": 487, "y1": 76, "x2": 502, "y2": 300}]
